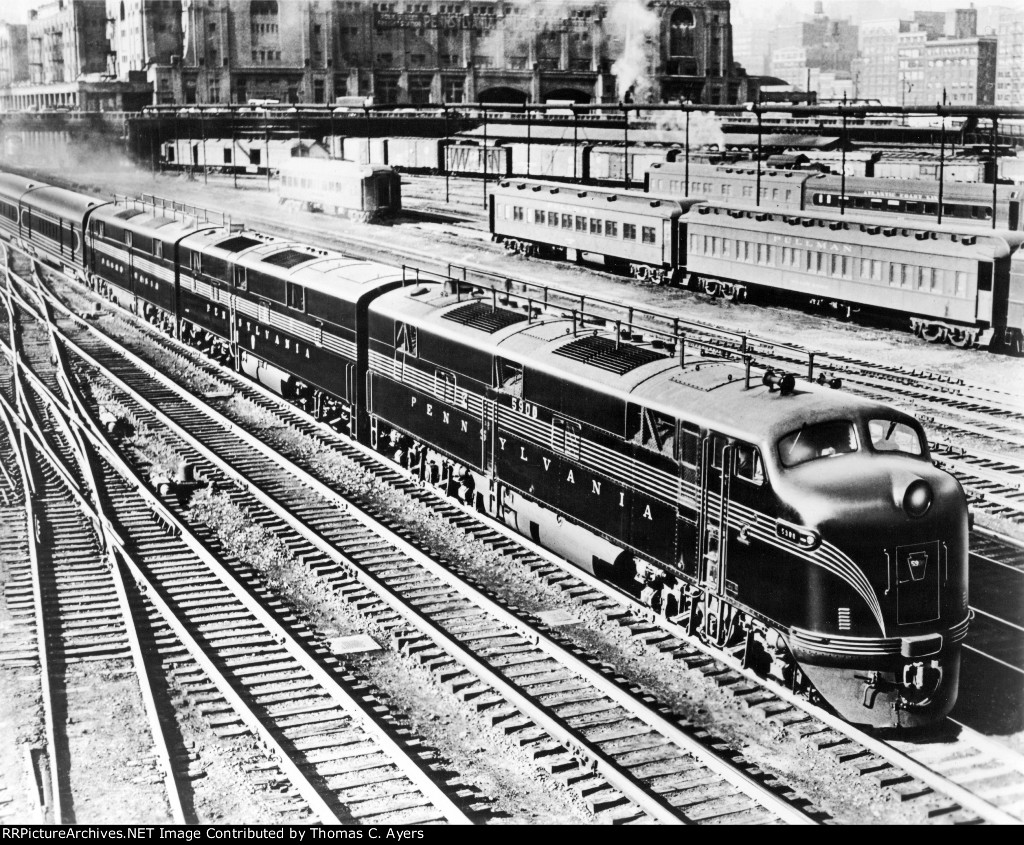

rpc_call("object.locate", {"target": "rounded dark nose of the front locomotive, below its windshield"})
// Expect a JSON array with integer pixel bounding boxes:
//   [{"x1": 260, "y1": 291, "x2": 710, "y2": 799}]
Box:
[{"x1": 774, "y1": 454, "x2": 970, "y2": 727}]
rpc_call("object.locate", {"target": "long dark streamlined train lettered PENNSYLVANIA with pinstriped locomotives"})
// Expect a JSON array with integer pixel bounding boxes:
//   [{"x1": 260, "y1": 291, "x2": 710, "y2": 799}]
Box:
[{"x1": 0, "y1": 170, "x2": 970, "y2": 727}]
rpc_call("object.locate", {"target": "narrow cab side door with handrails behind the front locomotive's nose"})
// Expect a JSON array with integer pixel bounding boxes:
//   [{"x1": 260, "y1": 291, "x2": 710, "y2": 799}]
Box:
[{"x1": 696, "y1": 431, "x2": 734, "y2": 594}]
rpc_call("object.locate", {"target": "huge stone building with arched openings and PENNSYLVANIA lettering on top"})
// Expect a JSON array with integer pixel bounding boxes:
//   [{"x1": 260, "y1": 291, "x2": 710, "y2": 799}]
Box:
[{"x1": 151, "y1": 0, "x2": 748, "y2": 104}]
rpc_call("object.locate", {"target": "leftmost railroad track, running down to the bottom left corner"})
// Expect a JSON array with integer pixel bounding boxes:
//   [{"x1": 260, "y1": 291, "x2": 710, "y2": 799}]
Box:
[{"x1": 0, "y1": 280, "x2": 184, "y2": 823}]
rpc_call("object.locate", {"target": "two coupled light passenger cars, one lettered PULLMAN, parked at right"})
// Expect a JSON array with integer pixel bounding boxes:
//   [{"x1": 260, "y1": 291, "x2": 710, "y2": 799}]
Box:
[{"x1": 489, "y1": 179, "x2": 1024, "y2": 353}]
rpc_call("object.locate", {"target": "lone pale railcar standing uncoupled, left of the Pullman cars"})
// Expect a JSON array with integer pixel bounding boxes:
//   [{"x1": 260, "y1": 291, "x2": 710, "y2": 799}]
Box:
[{"x1": 278, "y1": 159, "x2": 401, "y2": 222}]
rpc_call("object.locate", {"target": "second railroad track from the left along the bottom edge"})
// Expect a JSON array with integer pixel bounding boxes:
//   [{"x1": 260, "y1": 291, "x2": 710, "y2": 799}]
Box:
[{"x1": 1, "y1": 268, "x2": 479, "y2": 825}]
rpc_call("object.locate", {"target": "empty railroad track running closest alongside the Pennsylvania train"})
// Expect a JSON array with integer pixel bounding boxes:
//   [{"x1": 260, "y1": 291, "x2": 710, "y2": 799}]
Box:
[{"x1": 24, "y1": 274, "x2": 813, "y2": 822}]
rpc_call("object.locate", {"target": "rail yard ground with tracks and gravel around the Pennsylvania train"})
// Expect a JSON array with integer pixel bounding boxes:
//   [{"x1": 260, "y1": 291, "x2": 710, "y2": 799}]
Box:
[{"x1": 0, "y1": 135, "x2": 1024, "y2": 825}]
